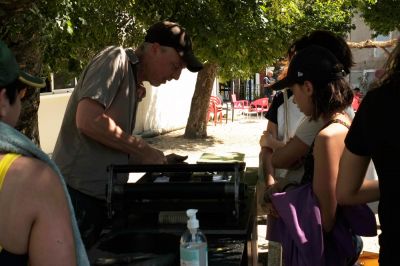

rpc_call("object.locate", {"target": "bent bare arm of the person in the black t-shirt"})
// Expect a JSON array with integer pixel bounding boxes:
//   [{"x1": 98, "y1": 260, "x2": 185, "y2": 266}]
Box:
[{"x1": 336, "y1": 148, "x2": 380, "y2": 205}]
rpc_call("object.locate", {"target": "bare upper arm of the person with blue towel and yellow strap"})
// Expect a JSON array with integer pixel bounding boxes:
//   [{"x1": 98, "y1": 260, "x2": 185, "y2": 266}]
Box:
[{"x1": 28, "y1": 159, "x2": 76, "y2": 266}]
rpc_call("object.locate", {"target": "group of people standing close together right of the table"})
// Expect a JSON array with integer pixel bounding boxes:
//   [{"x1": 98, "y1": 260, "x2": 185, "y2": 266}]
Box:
[{"x1": 260, "y1": 31, "x2": 400, "y2": 265}]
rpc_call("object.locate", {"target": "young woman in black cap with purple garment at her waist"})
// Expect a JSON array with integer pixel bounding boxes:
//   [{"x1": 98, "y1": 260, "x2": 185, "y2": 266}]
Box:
[{"x1": 269, "y1": 45, "x2": 376, "y2": 266}]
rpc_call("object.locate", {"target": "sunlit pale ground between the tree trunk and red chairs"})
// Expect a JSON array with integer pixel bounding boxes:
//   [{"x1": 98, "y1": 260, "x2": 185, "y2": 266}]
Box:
[{"x1": 148, "y1": 116, "x2": 379, "y2": 265}]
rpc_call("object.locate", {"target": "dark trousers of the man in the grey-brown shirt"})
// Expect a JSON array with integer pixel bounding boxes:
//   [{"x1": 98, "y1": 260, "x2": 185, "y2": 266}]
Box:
[{"x1": 68, "y1": 186, "x2": 107, "y2": 250}]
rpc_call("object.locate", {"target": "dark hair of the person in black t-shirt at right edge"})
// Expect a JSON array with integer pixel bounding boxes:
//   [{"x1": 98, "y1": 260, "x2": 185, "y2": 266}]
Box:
[{"x1": 371, "y1": 39, "x2": 400, "y2": 89}]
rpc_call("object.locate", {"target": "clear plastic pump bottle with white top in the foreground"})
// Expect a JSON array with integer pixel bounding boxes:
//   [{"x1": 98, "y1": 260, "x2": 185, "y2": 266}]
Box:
[{"x1": 180, "y1": 209, "x2": 208, "y2": 266}]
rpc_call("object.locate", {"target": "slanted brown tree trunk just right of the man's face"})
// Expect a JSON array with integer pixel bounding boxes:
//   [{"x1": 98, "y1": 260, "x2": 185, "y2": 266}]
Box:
[{"x1": 184, "y1": 63, "x2": 218, "y2": 139}]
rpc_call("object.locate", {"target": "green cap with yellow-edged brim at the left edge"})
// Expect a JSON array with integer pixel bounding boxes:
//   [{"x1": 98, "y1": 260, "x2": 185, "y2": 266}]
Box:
[{"x1": 0, "y1": 40, "x2": 46, "y2": 88}]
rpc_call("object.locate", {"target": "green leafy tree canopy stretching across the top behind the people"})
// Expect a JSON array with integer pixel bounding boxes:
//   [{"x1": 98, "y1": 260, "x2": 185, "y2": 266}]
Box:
[{"x1": 0, "y1": 0, "x2": 372, "y2": 141}]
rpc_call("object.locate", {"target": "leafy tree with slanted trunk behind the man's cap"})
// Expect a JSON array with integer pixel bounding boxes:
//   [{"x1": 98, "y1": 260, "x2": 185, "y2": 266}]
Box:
[{"x1": 128, "y1": 0, "x2": 353, "y2": 138}]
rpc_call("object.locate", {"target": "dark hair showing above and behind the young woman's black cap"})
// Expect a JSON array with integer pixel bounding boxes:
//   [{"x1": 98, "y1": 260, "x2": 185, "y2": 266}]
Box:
[{"x1": 288, "y1": 30, "x2": 354, "y2": 74}]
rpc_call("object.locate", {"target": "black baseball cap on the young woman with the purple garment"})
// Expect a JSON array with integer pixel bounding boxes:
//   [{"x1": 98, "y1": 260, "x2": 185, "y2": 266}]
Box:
[{"x1": 269, "y1": 45, "x2": 346, "y2": 90}]
